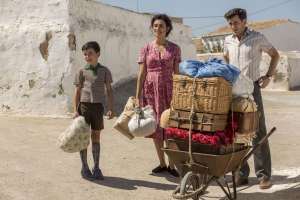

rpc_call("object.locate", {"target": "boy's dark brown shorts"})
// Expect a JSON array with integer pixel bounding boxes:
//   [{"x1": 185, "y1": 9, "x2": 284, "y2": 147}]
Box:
[{"x1": 78, "y1": 102, "x2": 104, "y2": 131}]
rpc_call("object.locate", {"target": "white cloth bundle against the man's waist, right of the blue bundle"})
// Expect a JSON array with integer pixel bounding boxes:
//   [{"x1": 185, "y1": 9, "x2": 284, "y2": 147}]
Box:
[{"x1": 232, "y1": 74, "x2": 254, "y2": 99}]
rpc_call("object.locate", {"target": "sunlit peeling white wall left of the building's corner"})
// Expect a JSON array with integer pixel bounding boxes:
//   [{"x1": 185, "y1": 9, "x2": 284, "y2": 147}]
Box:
[{"x1": 0, "y1": 0, "x2": 69, "y2": 114}]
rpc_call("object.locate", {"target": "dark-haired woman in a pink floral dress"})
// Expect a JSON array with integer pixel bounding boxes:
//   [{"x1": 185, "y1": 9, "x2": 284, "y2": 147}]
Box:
[{"x1": 136, "y1": 14, "x2": 181, "y2": 176}]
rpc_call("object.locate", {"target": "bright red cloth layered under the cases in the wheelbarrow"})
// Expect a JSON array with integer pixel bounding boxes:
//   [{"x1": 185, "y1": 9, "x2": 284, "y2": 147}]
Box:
[{"x1": 165, "y1": 116, "x2": 237, "y2": 147}]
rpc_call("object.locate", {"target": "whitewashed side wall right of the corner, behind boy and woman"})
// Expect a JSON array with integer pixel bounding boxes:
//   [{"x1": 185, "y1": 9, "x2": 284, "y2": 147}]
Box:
[{"x1": 69, "y1": 0, "x2": 196, "y2": 82}]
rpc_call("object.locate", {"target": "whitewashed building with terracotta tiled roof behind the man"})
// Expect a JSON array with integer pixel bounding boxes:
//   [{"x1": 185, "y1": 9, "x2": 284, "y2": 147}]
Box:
[{"x1": 193, "y1": 20, "x2": 300, "y2": 90}]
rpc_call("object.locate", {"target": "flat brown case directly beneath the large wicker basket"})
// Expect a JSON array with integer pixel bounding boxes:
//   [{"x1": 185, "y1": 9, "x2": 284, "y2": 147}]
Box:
[{"x1": 169, "y1": 110, "x2": 227, "y2": 132}]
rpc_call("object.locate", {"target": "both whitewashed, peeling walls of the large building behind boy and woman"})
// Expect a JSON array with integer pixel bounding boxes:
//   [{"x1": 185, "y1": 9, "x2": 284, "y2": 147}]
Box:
[{"x1": 0, "y1": 0, "x2": 196, "y2": 116}]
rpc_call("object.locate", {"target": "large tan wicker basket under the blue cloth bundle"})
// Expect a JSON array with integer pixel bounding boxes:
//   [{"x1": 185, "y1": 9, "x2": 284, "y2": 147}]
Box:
[{"x1": 171, "y1": 75, "x2": 232, "y2": 114}]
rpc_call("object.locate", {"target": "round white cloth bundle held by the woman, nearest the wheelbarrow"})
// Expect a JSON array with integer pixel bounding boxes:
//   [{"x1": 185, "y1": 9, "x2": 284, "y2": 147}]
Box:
[{"x1": 128, "y1": 105, "x2": 157, "y2": 137}]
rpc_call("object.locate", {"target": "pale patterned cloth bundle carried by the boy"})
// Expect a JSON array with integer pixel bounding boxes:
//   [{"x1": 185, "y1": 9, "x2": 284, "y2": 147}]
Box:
[{"x1": 58, "y1": 116, "x2": 91, "y2": 153}]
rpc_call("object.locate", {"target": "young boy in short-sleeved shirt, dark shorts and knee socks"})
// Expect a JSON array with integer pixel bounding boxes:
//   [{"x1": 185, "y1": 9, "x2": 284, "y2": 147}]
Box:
[{"x1": 74, "y1": 41, "x2": 113, "y2": 180}]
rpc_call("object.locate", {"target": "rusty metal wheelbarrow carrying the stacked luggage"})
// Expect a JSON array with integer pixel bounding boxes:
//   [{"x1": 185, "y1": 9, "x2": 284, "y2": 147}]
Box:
[{"x1": 162, "y1": 127, "x2": 276, "y2": 200}]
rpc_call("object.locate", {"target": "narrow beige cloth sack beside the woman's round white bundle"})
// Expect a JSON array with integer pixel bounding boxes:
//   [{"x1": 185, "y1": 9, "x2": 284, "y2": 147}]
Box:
[{"x1": 113, "y1": 97, "x2": 135, "y2": 140}]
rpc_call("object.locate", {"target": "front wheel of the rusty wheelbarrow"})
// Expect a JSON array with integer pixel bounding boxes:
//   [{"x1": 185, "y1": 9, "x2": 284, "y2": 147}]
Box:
[{"x1": 179, "y1": 172, "x2": 200, "y2": 200}]
